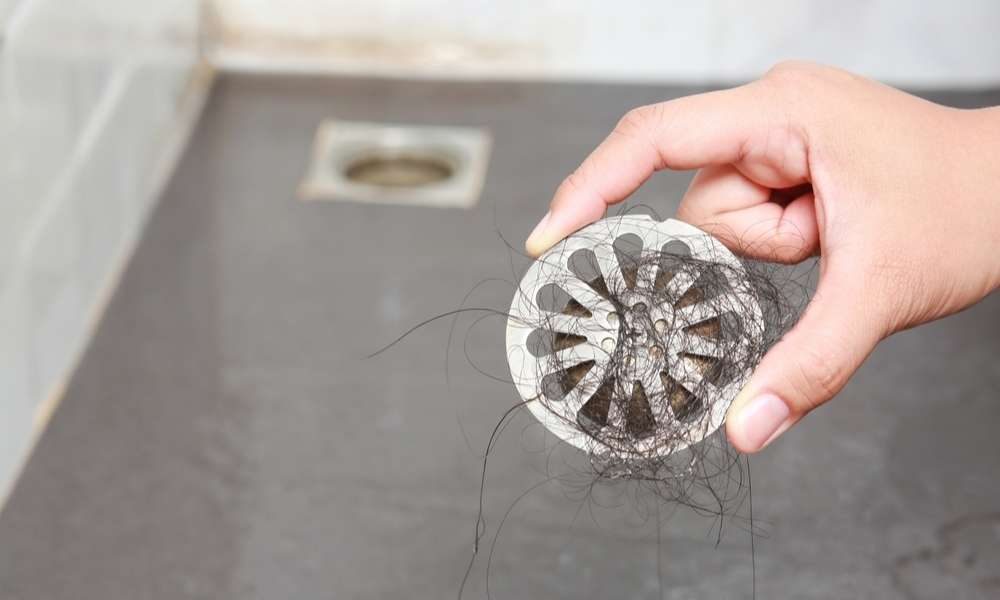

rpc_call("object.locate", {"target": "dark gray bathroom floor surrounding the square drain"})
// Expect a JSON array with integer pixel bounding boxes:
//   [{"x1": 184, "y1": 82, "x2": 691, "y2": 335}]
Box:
[{"x1": 0, "y1": 76, "x2": 1000, "y2": 600}]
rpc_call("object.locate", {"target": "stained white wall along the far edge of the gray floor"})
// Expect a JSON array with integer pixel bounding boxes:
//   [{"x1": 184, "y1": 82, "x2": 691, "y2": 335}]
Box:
[{"x1": 212, "y1": 0, "x2": 1000, "y2": 86}]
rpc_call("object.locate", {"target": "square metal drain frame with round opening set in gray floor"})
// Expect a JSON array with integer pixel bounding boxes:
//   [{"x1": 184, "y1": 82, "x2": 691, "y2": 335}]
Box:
[{"x1": 298, "y1": 120, "x2": 491, "y2": 208}]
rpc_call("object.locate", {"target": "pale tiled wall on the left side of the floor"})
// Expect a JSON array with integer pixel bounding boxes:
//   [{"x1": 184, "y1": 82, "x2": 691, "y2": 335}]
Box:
[{"x1": 0, "y1": 0, "x2": 207, "y2": 500}]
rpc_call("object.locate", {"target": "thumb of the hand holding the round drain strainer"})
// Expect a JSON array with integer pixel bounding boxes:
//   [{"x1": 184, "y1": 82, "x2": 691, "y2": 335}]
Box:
[{"x1": 726, "y1": 268, "x2": 885, "y2": 453}]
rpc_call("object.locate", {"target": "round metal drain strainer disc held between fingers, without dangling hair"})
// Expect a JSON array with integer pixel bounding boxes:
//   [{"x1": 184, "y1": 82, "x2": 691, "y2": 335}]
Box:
[{"x1": 507, "y1": 215, "x2": 763, "y2": 459}]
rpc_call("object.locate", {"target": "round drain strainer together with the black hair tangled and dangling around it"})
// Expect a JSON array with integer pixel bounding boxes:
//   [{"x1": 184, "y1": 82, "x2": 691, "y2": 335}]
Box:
[{"x1": 373, "y1": 209, "x2": 813, "y2": 598}]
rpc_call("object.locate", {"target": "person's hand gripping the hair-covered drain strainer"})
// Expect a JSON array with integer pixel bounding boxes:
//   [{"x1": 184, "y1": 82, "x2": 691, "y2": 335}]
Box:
[{"x1": 527, "y1": 63, "x2": 1000, "y2": 452}]
